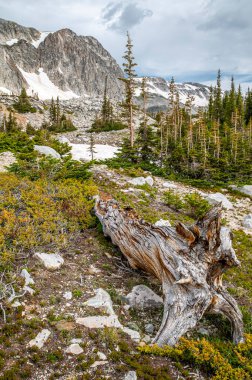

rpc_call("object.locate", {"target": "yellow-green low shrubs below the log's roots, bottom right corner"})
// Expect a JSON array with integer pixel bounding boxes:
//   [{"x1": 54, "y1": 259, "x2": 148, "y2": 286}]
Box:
[{"x1": 138, "y1": 334, "x2": 252, "y2": 380}]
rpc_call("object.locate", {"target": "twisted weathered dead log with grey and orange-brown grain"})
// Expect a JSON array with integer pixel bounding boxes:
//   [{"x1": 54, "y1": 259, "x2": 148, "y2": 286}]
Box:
[{"x1": 95, "y1": 199, "x2": 244, "y2": 345}]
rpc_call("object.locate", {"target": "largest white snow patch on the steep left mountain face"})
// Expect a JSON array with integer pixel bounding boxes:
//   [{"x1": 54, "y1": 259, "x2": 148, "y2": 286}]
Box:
[{"x1": 18, "y1": 67, "x2": 79, "y2": 100}]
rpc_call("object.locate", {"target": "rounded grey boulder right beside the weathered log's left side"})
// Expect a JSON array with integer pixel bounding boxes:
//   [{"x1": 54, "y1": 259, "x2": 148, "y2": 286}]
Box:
[{"x1": 126, "y1": 285, "x2": 163, "y2": 309}]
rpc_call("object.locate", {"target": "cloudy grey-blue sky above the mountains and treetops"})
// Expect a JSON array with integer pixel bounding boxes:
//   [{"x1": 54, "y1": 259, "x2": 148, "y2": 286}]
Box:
[{"x1": 0, "y1": 0, "x2": 252, "y2": 88}]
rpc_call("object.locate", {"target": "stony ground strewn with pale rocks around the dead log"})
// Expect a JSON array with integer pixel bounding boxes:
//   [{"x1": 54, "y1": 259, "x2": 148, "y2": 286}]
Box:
[{"x1": 0, "y1": 165, "x2": 252, "y2": 380}]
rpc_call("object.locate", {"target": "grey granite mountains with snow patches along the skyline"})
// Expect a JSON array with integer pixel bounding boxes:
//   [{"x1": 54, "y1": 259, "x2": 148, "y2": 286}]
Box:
[{"x1": 0, "y1": 19, "x2": 209, "y2": 107}]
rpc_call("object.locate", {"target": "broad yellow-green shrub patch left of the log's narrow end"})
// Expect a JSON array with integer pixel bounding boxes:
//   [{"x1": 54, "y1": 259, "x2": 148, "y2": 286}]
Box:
[{"x1": 0, "y1": 174, "x2": 96, "y2": 268}]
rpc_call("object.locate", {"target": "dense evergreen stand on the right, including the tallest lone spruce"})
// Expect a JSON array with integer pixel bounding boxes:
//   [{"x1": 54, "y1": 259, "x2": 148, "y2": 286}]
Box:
[{"x1": 118, "y1": 36, "x2": 252, "y2": 181}]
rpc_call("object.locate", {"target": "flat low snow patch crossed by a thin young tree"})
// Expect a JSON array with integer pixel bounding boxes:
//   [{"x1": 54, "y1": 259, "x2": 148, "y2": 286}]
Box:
[{"x1": 69, "y1": 143, "x2": 119, "y2": 161}]
